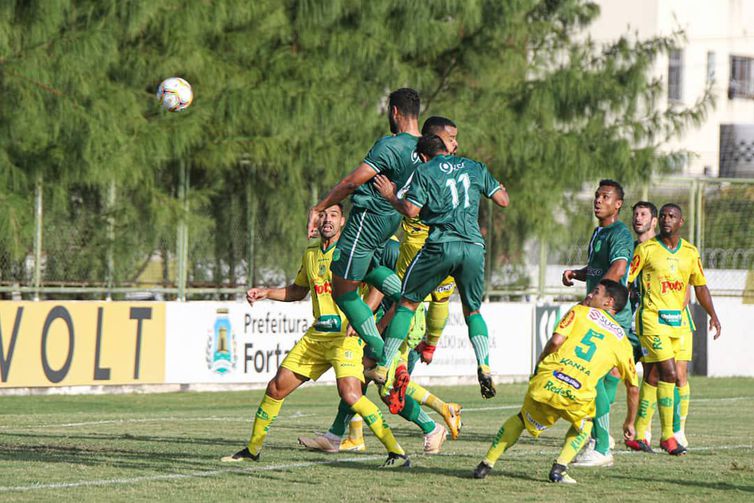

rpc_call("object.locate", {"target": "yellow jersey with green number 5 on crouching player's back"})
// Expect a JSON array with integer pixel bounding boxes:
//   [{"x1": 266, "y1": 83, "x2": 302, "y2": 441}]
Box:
[{"x1": 528, "y1": 305, "x2": 639, "y2": 412}]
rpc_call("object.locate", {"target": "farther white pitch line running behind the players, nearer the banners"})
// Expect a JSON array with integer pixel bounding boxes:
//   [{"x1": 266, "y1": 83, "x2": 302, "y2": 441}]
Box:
[{"x1": 0, "y1": 396, "x2": 754, "y2": 432}]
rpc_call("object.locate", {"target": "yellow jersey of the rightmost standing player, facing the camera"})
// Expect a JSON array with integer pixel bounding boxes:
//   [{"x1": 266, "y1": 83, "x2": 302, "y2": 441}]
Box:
[{"x1": 628, "y1": 238, "x2": 707, "y2": 337}]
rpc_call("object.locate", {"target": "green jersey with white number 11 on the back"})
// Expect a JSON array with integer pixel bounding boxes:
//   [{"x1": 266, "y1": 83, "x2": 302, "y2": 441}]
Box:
[{"x1": 405, "y1": 155, "x2": 500, "y2": 246}]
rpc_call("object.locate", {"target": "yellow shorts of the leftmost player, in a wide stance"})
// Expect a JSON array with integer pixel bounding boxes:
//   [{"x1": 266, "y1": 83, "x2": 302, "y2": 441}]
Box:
[{"x1": 281, "y1": 329, "x2": 364, "y2": 382}]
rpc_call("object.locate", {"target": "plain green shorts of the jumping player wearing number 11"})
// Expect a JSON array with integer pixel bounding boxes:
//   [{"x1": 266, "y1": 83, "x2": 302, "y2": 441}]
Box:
[{"x1": 401, "y1": 241, "x2": 484, "y2": 311}]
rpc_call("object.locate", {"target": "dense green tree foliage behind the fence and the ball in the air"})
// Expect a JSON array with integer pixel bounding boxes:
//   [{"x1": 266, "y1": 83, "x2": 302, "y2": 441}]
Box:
[{"x1": 0, "y1": 0, "x2": 711, "y2": 292}]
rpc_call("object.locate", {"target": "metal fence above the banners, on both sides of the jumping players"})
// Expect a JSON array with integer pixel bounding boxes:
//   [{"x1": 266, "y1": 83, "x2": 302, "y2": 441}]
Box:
[{"x1": 0, "y1": 173, "x2": 754, "y2": 300}]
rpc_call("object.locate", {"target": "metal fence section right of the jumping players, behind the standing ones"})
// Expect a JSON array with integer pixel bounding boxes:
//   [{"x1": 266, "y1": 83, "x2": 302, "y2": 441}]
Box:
[{"x1": 487, "y1": 177, "x2": 754, "y2": 301}]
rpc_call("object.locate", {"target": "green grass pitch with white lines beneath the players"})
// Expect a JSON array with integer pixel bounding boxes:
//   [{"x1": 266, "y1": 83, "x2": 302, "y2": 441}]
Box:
[{"x1": 0, "y1": 378, "x2": 754, "y2": 502}]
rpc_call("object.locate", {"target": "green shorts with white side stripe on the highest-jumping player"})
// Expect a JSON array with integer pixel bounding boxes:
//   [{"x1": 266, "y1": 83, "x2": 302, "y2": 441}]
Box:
[{"x1": 330, "y1": 208, "x2": 401, "y2": 281}]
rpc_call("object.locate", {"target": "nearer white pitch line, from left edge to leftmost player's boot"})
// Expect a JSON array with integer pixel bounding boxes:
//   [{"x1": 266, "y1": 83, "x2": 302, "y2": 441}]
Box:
[{"x1": 0, "y1": 456, "x2": 384, "y2": 492}]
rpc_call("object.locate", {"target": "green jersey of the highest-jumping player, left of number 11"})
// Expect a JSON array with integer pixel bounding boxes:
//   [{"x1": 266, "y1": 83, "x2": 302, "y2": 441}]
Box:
[{"x1": 351, "y1": 133, "x2": 421, "y2": 215}]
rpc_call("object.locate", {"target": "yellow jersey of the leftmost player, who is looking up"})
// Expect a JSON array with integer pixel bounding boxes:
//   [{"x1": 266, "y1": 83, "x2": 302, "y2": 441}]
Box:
[{"x1": 294, "y1": 242, "x2": 348, "y2": 337}]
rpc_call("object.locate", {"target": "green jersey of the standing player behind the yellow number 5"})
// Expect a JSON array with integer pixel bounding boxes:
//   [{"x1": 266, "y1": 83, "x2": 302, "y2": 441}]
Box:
[{"x1": 586, "y1": 220, "x2": 634, "y2": 333}]
